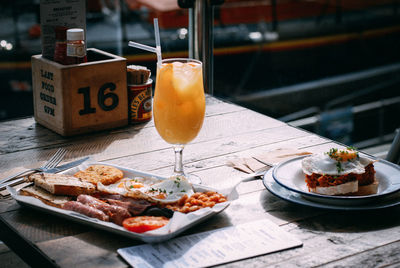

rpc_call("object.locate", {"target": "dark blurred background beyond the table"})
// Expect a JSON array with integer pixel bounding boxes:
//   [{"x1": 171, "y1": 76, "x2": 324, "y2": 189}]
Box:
[{"x1": 0, "y1": 0, "x2": 400, "y2": 153}]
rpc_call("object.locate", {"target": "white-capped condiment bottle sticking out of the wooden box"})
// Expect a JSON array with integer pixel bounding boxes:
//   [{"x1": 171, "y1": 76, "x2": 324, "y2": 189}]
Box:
[{"x1": 67, "y1": 28, "x2": 87, "y2": 64}]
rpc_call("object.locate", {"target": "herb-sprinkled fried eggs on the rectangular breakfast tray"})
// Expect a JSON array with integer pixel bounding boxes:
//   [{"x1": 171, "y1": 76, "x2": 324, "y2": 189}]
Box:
[{"x1": 97, "y1": 176, "x2": 194, "y2": 203}]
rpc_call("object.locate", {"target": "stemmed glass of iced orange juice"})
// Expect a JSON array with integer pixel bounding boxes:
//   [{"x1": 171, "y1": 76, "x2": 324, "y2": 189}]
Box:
[{"x1": 153, "y1": 58, "x2": 206, "y2": 183}]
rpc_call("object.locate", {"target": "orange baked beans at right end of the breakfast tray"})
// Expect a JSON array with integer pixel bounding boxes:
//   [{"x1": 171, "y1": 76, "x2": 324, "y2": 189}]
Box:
[{"x1": 166, "y1": 192, "x2": 227, "y2": 213}]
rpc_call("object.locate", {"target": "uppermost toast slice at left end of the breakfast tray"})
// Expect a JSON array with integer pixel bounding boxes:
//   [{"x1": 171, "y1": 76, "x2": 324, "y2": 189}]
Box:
[{"x1": 28, "y1": 173, "x2": 96, "y2": 196}]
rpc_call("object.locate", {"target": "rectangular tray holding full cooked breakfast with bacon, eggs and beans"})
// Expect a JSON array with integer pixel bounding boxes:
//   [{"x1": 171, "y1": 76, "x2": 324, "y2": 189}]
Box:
[{"x1": 7, "y1": 161, "x2": 238, "y2": 243}]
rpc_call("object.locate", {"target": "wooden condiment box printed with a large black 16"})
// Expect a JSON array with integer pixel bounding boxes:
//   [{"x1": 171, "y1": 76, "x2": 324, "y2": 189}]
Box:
[{"x1": 32, "y1": 48, "x2": 128, "y2": 136}]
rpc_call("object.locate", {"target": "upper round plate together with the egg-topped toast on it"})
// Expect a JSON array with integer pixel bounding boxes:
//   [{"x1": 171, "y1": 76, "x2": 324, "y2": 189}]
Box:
[{"x1": 272, "y1": 148, "x2": 400, "y2": 205}]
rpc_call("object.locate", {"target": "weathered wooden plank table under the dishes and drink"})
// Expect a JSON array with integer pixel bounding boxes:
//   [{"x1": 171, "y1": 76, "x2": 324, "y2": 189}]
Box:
[{"x1": 0, "y1": 97, "x2": 400, "y2": 267}]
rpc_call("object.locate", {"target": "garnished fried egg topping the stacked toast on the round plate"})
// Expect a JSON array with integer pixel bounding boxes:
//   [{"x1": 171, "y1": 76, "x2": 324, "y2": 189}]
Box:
[{"x1": 301, "y1": 149, "x2": 373, "y2": 176}]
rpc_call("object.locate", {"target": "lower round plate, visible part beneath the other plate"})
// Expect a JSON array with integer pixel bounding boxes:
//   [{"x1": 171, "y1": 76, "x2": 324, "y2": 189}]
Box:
[{"x1": 263, "y1": 169, "x2": 400, "y2": 211}]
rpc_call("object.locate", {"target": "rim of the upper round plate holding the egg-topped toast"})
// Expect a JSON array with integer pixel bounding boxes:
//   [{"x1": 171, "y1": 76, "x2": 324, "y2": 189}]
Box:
[{"x1": 272, "y1": 155, "x2": 400, "y2": 202}]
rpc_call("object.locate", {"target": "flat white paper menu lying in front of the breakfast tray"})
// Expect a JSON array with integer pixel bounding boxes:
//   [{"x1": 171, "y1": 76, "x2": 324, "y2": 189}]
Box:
[{"x1": 118, "y1": 220, "x2": 302, "y2": 268}]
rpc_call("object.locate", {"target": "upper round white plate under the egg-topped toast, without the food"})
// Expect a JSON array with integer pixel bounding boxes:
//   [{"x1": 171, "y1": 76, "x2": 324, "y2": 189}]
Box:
[{"x1": 272, "y1": 156, "x2": 400, "y2": 205}]
